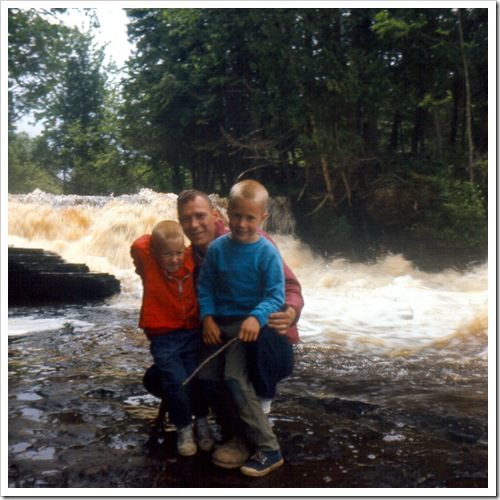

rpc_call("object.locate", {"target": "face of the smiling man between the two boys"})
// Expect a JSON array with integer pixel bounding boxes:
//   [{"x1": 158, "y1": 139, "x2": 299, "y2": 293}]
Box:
[{"x1": 179, "y1": 196, "x2": 217, "y2": 253}]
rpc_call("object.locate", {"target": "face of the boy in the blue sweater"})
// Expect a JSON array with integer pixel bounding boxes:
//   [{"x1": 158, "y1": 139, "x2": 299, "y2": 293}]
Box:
[{"x1": 227, "y1": 200, "x2": 268, "y2": 243}]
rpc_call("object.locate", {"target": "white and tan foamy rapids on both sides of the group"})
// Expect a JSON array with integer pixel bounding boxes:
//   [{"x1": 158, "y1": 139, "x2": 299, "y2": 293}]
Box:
[{"x1": 5, "y1": 190, "x2": 488, "y2": 358}]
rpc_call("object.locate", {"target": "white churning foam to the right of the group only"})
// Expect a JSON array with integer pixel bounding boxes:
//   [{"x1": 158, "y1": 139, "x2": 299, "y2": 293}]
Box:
[{"x1": 275, "y1": 235, "x2": 488, "y2": 356}]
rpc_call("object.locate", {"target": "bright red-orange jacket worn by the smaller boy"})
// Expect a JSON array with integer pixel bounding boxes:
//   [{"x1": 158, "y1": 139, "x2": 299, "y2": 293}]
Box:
[{"x1": 130, "y1": 234, "x2": 200, "y2": 336}]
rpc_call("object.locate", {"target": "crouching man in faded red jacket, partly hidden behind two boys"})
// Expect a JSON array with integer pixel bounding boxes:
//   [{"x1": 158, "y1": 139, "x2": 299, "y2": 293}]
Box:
[{"x1": 143, "y1": 189, "x2": 304, "y2": 468}]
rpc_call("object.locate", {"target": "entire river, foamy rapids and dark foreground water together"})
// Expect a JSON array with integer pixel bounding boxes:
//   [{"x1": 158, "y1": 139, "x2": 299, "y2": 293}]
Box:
[{"x1": 8, "y1": 190, "x2": 492, "y2": 494}]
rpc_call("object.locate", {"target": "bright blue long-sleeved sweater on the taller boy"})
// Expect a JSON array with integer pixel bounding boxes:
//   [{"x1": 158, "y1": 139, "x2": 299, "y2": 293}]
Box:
[{"x1": 198, "y1": 234, "x2": 285, "y2": 327}]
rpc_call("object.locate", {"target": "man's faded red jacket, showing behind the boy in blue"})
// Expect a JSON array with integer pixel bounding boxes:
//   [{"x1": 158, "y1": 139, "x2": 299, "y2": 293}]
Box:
[{"x1": 189, "y1": 219, "x2": 304, "y2": 344}]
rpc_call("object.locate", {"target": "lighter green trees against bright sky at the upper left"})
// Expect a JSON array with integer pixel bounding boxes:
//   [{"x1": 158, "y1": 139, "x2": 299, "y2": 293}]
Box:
[{"x1": 9, "y1": 9, "x2": 135, "y2": 194}]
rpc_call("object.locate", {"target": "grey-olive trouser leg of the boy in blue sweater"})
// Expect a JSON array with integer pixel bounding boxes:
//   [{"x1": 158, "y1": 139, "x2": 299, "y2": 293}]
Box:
[{"x1": 221, "y1": 322, "x2": 280, "y2": 452}]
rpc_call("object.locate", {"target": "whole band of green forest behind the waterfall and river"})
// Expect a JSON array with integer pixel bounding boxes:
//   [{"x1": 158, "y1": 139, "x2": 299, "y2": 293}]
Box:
[{"x1": 8, "y1": 8, "x2": 488, "y2": 258}]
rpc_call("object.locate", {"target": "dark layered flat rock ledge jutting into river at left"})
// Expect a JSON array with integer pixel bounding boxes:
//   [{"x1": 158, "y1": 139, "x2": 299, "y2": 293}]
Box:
[{"x1": 8, "y1": 247, "x2": 120, "y2": 306}]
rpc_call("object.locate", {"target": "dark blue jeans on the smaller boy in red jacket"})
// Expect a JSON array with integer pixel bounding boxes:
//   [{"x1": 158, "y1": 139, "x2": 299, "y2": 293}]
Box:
[{"x1": 150, "y1": 329, "x2": 201, "y2": 428}]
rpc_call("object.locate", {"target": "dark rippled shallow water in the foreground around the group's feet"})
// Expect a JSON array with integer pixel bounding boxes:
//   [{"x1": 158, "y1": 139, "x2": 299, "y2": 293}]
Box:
[{"x1": 8, "y1": 305, "x2": 488, "y2": 495}]
